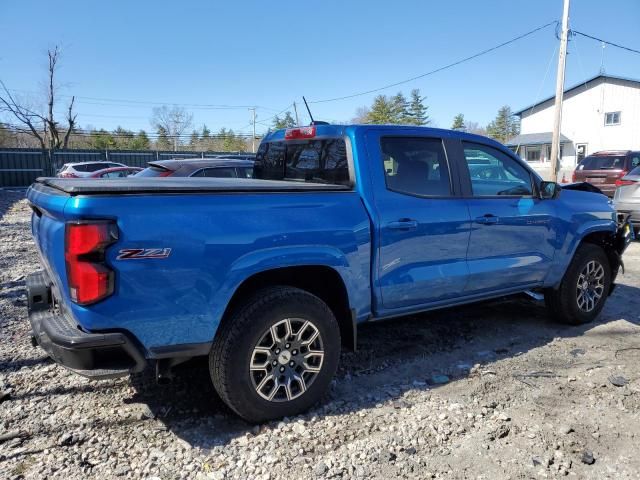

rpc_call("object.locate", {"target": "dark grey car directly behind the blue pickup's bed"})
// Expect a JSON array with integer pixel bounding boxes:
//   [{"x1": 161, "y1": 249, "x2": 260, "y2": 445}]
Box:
[{"x1": 136, "y1": 158, "x2": 254, "y2": 178}]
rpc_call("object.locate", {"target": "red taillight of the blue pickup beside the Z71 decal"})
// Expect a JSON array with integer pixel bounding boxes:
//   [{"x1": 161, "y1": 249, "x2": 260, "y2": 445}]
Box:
[{"x1": 64, "y1": 220, "x2": 118, "y2": 305}]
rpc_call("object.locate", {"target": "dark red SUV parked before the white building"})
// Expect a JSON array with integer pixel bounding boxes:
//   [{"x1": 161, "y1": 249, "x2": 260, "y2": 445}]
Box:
[{"x1": 572, "y1": 150, "x2": 640, "y2": 197}]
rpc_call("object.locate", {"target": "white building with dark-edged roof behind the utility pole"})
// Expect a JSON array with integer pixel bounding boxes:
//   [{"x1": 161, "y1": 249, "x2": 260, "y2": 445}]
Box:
[{"x1": 507, "y1": 74, "x2": 640, "y2": 177}]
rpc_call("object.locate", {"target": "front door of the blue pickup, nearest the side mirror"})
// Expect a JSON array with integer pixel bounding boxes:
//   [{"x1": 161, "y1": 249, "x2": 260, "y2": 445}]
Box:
[{"x1": 452, "y1": 141, "x2": 555, "y2": 294}]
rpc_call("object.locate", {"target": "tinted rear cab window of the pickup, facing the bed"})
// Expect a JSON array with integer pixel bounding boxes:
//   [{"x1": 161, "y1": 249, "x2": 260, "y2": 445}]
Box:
[{"x1": 253, "y1": 138, "x2": 350, "y2": 185}]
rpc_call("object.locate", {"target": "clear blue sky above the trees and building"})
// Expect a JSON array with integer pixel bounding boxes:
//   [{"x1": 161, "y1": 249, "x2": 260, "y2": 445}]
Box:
[{"x1": 0, "y1": 0, "x2": 640, "y2": 137}]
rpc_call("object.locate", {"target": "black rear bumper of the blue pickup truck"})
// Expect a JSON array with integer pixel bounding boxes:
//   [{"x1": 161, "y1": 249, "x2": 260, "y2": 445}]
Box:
[{"x1": 26, "y1": 272, "x2": 146, "y2": 379}]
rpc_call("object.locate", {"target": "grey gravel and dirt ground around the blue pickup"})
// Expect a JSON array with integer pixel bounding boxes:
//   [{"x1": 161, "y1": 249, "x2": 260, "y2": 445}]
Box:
[{"x1": 0, "y1": 191, "x2": 640, "y2": 480}]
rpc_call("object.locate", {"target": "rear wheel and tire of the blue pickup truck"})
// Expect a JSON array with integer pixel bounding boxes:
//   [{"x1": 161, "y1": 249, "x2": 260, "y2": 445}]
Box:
[{"x1": 209, "y1": 287, "x2": 341, "y2": 423}]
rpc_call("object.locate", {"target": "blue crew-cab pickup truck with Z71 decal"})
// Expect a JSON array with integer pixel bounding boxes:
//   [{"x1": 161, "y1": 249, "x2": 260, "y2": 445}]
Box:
[{"x1": 27, "y1": 124, "x2": 632, "y2": 422}]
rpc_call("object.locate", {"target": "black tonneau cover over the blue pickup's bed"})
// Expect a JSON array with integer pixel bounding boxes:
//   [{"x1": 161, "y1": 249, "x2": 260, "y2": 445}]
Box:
[{"x1": 36, "y1": 177, "x2": 351, "y2": 195}]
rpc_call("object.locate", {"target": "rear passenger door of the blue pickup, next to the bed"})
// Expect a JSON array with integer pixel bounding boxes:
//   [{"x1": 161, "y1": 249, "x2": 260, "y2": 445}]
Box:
[{"x1": 366, "y1": 128, "x2": 470, "y2": 315}]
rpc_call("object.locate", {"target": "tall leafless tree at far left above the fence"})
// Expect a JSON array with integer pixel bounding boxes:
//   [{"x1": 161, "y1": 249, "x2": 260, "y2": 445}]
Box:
[{"x1": 0, "y1": 46, "x2": 78, "y2": 150}]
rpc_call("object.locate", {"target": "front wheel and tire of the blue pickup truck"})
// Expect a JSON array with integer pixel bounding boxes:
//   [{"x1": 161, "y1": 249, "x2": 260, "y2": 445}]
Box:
[{"x1": 544, "y1": 243, "x2": 611, "y2": 325}]
